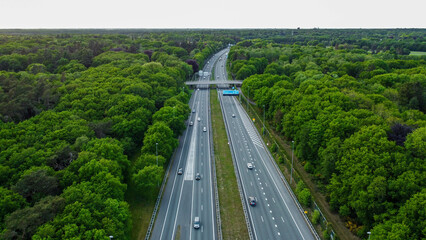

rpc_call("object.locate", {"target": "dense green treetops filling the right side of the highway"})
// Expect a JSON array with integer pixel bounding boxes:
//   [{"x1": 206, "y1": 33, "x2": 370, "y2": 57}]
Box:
[{"x1": 228, "y1": 35, "x2": 426, "y2": 239}]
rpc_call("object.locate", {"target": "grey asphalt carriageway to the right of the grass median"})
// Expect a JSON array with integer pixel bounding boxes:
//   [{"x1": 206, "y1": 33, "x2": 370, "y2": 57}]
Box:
[{"x1": 215, "y1": 51, "x2": 315, "y2": 240}]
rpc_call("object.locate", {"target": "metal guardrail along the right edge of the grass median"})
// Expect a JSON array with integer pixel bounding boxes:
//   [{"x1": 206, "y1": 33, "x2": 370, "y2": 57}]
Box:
[{"x1": 217, "y1": 91, "x2": 254, "y2": 240}]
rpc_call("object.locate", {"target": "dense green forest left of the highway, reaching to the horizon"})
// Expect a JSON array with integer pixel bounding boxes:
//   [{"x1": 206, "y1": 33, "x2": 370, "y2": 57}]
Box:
[{"x1": 0, "y1": 33, "x2": 230, "y2": 239}]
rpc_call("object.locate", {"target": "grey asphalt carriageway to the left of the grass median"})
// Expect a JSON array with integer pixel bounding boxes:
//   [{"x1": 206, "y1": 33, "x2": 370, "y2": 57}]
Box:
[{"x1": 151, "y1": 51, "x2": 218, "y2": 240}]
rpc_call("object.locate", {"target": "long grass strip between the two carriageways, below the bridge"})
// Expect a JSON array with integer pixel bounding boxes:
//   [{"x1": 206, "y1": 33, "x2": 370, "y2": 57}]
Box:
[{"x1": 210, "y1": 90, "x2": 249, "y2": 239}]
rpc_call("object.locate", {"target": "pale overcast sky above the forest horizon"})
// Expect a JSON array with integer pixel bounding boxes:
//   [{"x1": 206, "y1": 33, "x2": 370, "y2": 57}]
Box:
[{"x1": 0, "y1": 0, "x2": 426, "y2": 29}]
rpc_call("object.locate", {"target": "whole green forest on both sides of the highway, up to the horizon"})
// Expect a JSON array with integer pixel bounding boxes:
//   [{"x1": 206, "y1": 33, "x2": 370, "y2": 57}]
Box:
[{"x1": 0, "y1": 29, "x2": 426, "y2": 240}]
